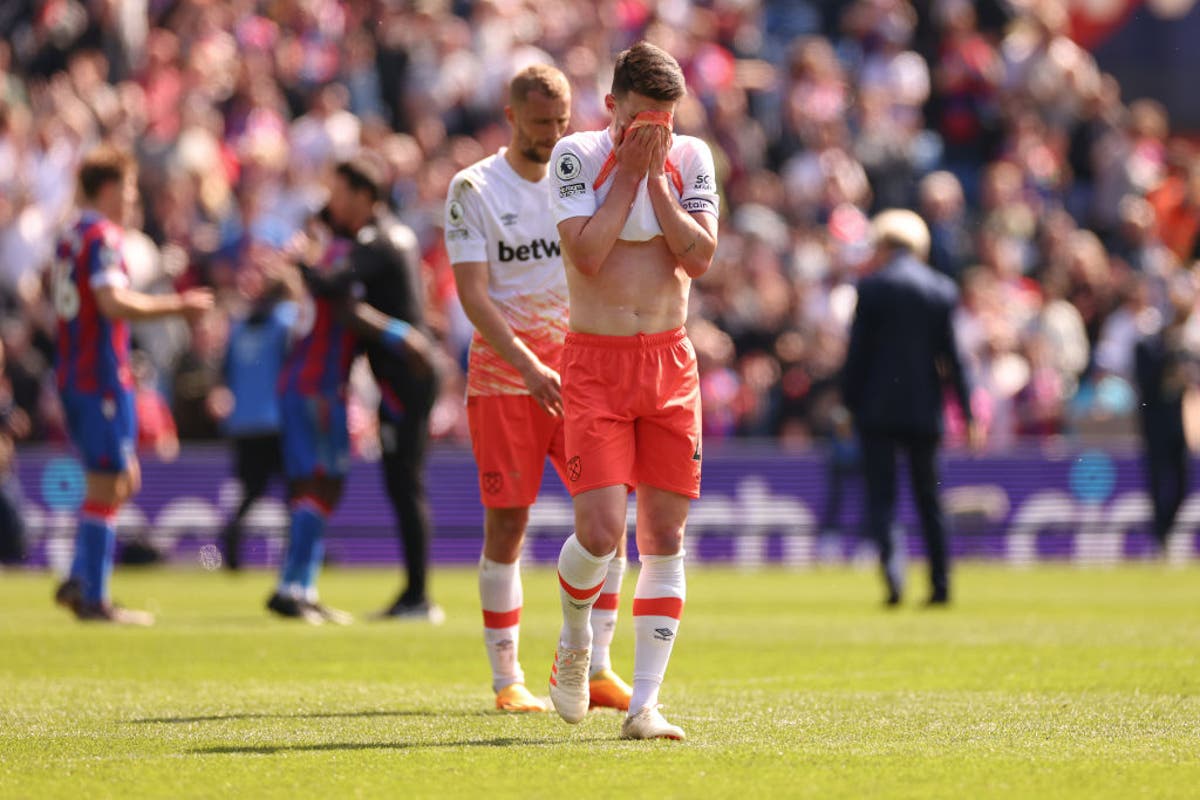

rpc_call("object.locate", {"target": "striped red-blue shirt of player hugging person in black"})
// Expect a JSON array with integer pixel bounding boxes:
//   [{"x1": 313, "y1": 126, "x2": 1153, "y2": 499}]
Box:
[{"x1": 278, "y1": 239, "x2": 359, "y2": 396}]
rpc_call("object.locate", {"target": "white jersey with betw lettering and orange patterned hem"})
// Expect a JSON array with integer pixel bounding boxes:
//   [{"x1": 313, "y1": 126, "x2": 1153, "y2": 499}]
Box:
[{"x1": 445, "y1": 148, "x2": 566, "y2": 395}]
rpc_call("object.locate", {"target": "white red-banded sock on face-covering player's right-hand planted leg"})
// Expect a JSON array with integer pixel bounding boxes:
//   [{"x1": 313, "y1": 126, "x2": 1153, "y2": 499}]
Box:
[{"x1": 629, "y1": 551, "x2": 688, "y2": 714}]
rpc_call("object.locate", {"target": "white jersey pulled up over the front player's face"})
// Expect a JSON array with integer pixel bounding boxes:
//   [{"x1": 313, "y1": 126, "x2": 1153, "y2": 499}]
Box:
[{"x1": 550, "y1": 128, "x2": 720, "y2": 241}]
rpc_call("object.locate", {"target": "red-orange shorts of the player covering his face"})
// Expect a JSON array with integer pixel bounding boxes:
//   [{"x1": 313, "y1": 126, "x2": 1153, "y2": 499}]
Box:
[{"x1": 562, "y1": 327, "x2": 700, "y2": 498}]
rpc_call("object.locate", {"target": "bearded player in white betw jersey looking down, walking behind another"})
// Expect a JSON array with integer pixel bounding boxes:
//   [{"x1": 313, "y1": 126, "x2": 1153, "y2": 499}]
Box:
[{"x1": 445, "y1": 65, "x2": 630, "y2": 711}]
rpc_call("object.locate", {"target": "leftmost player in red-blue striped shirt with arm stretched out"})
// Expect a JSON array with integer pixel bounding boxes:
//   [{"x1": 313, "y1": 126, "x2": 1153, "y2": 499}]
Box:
[{"x1": 49, "y1": 145, "x2": 212, "y2": 625}]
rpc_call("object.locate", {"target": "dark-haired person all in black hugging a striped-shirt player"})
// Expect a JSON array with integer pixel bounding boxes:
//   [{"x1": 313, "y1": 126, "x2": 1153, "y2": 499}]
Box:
[{"x1": 308, "y1": 150, "x2": 444, "y2": 624}]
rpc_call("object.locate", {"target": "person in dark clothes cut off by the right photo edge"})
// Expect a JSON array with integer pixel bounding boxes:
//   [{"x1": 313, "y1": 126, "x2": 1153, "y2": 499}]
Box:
[{"x1": 1134, "y1": 275, "x2": 1198, "y2": 552}]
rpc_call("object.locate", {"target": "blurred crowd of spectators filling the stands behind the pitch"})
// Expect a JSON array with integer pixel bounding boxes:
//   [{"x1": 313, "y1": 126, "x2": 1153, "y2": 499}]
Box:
[{"x1": 0, "y1": 0, "x2": 1200, "y2": 457}]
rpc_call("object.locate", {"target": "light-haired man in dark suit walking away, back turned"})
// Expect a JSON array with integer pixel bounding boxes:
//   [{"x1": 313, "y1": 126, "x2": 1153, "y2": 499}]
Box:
[{"x1": 842, "y1": 209, "x2": 979, "y2": 606}]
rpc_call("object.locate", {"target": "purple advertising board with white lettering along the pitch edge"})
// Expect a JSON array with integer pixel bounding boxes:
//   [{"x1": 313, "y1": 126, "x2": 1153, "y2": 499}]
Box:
[{"x1": 17, "y1": 443, "x2": 1200, "y2": 570}]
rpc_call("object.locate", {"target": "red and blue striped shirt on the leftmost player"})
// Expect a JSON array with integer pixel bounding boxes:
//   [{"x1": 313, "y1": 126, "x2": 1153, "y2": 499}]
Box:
[{"x1": 50, "y1": 211, "x2": 133, "y2": 393}]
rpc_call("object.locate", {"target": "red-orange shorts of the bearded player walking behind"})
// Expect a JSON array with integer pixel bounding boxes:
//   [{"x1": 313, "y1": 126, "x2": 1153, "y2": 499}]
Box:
[{"x1": 467, "y1": 395, "x2": 566, "y2": 509}]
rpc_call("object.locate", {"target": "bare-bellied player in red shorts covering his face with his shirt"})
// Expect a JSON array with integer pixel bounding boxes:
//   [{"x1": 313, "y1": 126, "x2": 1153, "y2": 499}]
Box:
[{"x1": 550, "y1": 42, "x2": 719, "y2": 739}]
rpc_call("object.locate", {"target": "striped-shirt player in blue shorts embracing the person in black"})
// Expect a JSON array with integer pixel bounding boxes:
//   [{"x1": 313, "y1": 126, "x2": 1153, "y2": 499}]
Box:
[{"x1": 266, "y1": 181, "x2": 432, "y2": 624}]
